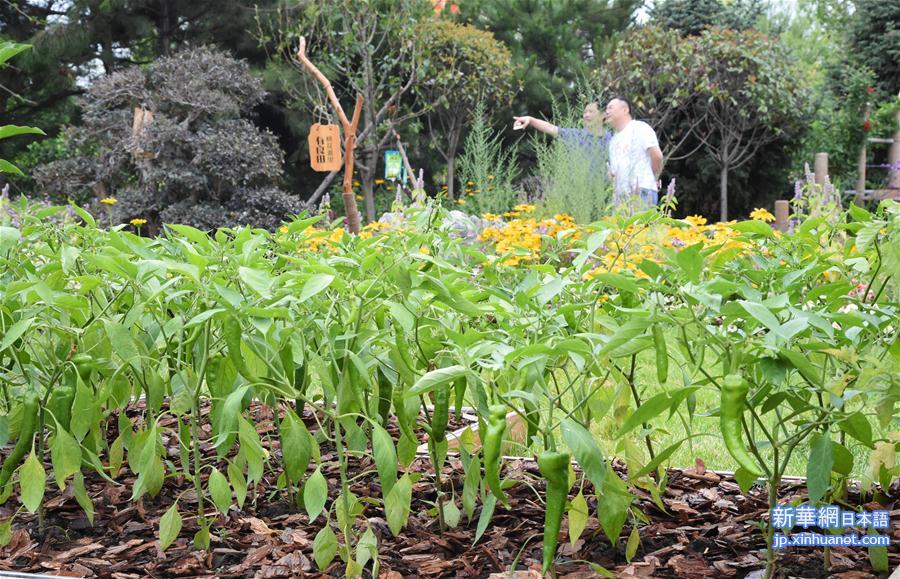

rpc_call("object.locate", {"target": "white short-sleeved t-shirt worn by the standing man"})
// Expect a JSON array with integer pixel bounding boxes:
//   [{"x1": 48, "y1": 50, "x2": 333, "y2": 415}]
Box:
[{"x1": 609, "y1": 120, "x2": 659, "y2": 195}]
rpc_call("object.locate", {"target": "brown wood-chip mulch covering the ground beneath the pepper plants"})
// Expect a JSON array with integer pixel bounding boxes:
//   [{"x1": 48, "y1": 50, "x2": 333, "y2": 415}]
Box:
[{"x1": 0, "y1": 409, "x2": 900, "y2": 579}]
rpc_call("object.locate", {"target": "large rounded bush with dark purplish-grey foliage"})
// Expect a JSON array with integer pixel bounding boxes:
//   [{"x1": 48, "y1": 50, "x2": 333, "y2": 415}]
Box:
[{"x1": 35, "y1": 48, "x2": 301, "y2": 232}]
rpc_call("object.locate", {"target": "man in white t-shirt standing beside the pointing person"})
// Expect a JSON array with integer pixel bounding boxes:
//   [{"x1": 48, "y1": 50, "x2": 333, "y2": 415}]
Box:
[{"x1": 606, "y1": 97, "x2": 663, "y2": 206}]
